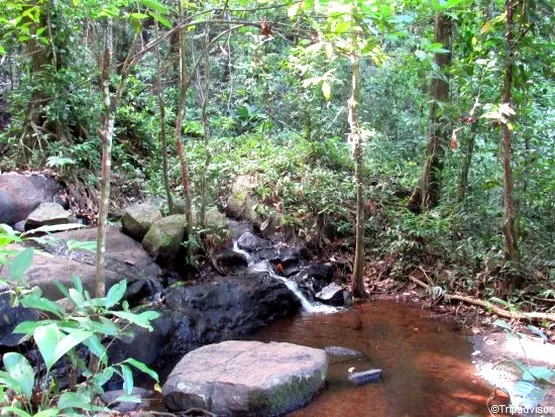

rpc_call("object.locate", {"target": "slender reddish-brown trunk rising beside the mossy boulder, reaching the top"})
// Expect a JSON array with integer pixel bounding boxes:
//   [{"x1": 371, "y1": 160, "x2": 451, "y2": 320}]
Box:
[{"x1": 174, "y1": 1, "x2": 193, "y2": 240}]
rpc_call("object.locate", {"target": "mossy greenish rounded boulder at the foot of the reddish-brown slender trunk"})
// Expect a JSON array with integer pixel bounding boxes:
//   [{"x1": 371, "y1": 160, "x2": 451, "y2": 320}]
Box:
[{"x1": 143, "y1": 214, "x2": 187, "y2": 265}]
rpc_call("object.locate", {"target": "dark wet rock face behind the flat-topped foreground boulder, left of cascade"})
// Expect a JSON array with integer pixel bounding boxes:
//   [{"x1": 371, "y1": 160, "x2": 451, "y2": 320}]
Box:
[{"x1": 110, "y1": 273, "x2": 299, "y2": 375}]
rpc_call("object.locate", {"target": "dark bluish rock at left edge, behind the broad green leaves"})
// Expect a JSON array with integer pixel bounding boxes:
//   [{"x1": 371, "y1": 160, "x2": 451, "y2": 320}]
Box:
[{"x1": 0, "y1": 284, "x2": 39, "y2": 352}]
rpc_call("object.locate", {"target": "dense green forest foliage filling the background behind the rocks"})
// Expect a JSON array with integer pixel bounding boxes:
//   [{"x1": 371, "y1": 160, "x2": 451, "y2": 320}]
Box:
[{"x1": 0, "y1": 0, "x2": 555, "y2": 300}]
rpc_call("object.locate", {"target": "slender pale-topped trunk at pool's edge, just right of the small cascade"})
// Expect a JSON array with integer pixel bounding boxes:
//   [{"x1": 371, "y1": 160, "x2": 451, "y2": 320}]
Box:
[{"x1": 348, "y1": 48, "x2": 366, "y2": 297}]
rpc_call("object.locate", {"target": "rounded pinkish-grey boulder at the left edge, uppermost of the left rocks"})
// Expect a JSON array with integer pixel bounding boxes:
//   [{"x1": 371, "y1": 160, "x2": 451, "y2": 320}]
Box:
[{"x1": 0, "y1": 173, "x2": 62, "y2": 225}]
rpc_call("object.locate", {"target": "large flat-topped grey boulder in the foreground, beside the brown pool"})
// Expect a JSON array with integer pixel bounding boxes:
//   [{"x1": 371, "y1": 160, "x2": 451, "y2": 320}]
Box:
[{"x1": 163, "y1": 340, "x2": 328, "y2": 417}]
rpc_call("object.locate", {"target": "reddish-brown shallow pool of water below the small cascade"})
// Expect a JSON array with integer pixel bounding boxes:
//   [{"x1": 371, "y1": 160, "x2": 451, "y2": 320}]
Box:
[{"x1": 251, "y1": 301, "x2": 502, "y2": 417}]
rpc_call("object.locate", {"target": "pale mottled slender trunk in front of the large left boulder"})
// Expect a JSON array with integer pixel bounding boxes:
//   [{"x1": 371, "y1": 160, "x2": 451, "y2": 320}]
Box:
[{"x1": 95, "y1": 23, "x2": 115, "y2": 297}]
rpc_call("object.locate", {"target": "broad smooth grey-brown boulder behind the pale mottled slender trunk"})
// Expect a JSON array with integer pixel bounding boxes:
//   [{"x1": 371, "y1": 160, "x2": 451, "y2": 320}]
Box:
[{"x1": 17, "y1": 228, "x2": 162, "y2": 300}]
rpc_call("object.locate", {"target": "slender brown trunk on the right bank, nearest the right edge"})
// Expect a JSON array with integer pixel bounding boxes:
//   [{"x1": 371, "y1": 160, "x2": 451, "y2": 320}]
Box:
[{"x1": 501, "y1": 0, "x2": 522, "y2": 289}]
